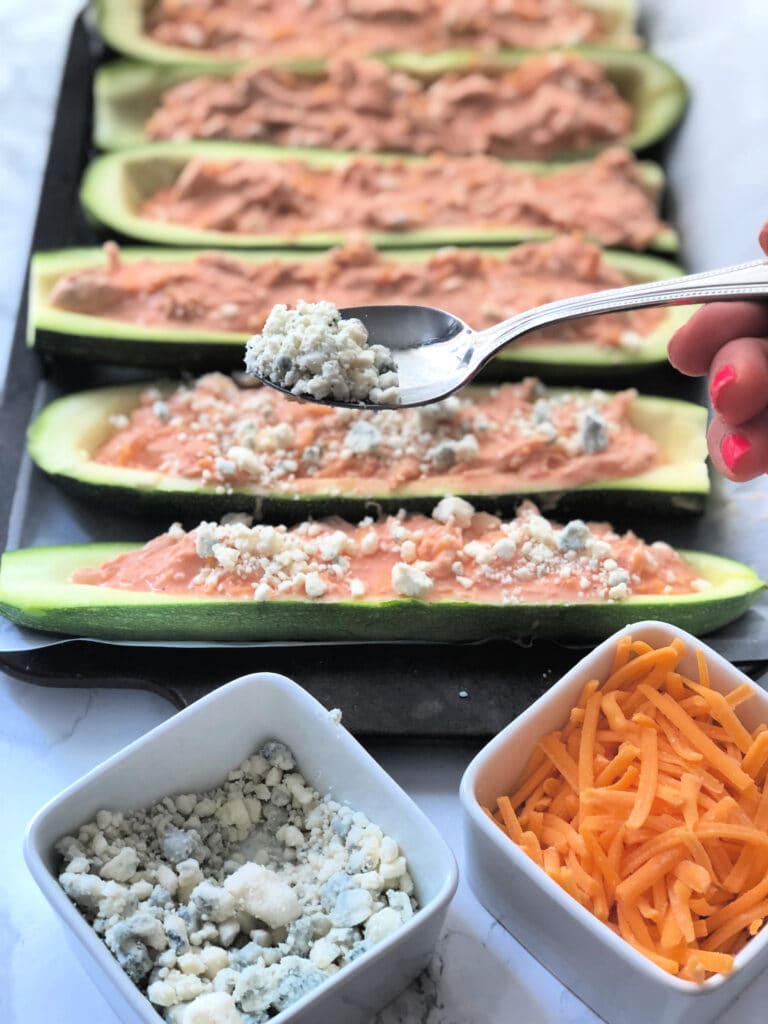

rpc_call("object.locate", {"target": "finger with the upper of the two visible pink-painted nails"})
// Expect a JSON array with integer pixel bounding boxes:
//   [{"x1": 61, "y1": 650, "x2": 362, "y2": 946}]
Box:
[{"x1": 710, "y1": 338, "x2": 768, "y2": 426}]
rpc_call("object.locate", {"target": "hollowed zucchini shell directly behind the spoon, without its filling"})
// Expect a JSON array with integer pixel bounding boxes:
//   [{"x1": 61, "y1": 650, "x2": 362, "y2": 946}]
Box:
[{"x1": 27, "y1": 247, "x2": 691, "y2": 383}]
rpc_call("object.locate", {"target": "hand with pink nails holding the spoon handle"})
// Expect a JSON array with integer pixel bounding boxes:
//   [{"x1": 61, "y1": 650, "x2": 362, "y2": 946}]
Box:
[{"x1": 669, "y1": 223, "x2": 768, "y2": 481}]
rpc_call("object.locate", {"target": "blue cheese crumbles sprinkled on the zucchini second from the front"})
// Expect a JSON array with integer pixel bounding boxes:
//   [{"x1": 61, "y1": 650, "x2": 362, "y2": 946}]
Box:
[{"x1": 123, "y1": 374, "x2": 643, "y2": 494}]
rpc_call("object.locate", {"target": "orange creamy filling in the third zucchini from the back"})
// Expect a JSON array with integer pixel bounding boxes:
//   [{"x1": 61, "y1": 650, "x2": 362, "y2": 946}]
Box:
[{"x1": 138, "y1": 150, "x2": 663, "y2": 249}]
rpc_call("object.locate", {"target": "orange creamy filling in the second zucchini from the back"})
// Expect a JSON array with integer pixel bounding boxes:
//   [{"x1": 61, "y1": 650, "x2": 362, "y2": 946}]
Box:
[{"x1": 146, "y1": 53, "x2": 634, "y2": 160}]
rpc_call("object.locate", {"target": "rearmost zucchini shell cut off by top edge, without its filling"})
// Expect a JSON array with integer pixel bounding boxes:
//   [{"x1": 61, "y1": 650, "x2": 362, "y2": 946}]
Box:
[{"x1": 95, "y1": 0, "x2": 638, "y2": 70}]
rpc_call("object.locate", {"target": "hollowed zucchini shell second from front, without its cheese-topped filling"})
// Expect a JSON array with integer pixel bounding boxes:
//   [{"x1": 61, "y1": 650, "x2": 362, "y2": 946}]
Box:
[{"x1": 28, "y1": 382, "x2": 710, "y2": 522}]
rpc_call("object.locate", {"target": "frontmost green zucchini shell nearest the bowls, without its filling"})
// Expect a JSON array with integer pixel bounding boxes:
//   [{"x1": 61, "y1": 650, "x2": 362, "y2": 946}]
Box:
[{"x1": 0, "y1": 544, "x2": 764, "y2": 642}]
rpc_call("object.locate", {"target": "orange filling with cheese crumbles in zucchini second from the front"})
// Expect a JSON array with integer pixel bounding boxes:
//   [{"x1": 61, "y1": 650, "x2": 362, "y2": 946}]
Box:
[{"x1": 94, "y1": 374, "x2": 660, "y2": 495}]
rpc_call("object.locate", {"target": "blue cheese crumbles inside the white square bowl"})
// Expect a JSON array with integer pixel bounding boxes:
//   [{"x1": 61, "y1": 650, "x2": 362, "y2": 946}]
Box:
[{"x1": 56, "y1": 740, "x2": 418, "y2": 1024}]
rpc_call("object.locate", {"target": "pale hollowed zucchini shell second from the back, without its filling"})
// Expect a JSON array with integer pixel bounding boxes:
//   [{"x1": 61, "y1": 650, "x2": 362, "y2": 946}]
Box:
[{"x1": 93, "y1": 47, "x2": 687, "y2": 160}]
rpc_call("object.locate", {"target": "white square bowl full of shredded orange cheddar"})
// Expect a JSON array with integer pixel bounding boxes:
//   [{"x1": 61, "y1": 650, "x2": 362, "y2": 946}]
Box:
[{"x1": 461, "y1": 622, "x2": 768, "y2": 1024}]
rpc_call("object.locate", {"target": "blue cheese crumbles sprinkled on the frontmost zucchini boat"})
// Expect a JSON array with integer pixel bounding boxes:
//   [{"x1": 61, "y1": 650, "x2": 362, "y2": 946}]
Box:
[{"x1": 163, "y1": 495, "x2": 706, "y2": 606}]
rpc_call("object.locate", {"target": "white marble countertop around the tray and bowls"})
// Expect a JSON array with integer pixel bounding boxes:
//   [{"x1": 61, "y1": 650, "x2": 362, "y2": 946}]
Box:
[{"x1": 0, "y1": 0, "x2": 768, "y2": 1024}]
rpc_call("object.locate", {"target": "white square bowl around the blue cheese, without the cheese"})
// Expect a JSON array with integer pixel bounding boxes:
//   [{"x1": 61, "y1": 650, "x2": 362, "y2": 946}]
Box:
[{"x1": 25, "y1": 673, "x2": 458, "y2": 1024}]
